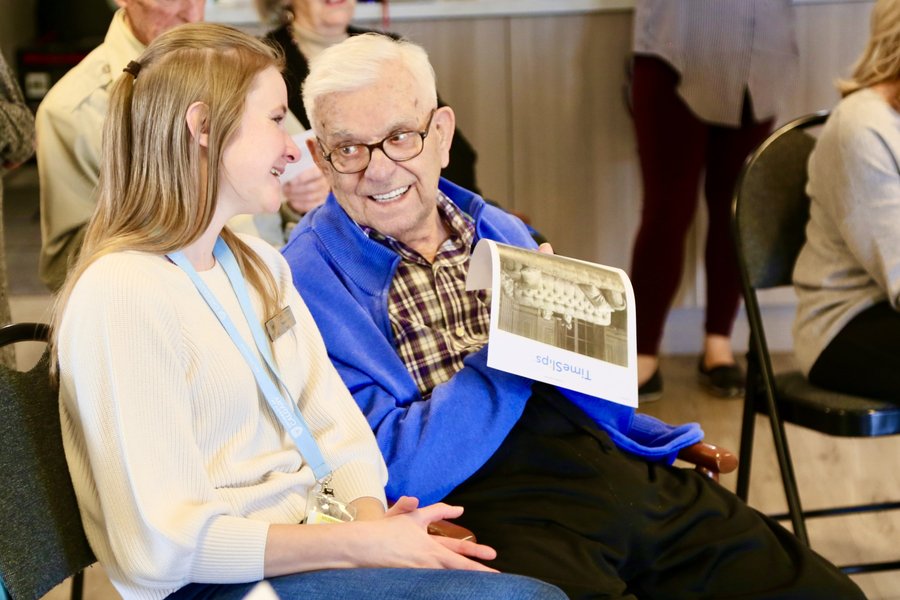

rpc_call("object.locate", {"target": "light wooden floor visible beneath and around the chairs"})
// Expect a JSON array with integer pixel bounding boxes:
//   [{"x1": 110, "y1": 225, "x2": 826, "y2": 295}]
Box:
[{"x1": 4, "y1": 167, "x2": 900, "y2": 600}]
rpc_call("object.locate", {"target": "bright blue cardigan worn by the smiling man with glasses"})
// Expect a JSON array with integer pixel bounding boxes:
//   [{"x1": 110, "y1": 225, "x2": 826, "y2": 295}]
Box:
[{"x1": 282, "y1": 179, "x2": 703, "y2": 503}]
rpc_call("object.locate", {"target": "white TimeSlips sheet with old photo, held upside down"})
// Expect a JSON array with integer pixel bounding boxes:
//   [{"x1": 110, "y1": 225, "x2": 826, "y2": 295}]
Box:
[{"x1": 466, "y1": 240, "x2": 638, "y2": 407}]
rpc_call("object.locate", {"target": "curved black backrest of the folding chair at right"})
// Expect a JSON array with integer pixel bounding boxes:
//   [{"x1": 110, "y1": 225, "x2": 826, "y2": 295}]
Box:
[{"x1": 732, "y1": 111, "x2": 828, "y2": 289}]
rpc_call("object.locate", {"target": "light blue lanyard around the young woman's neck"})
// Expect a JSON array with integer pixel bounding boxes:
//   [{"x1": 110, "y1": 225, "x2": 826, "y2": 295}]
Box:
[{"x1": 167, "y1": 237, "x2": 331, "y2": 481}]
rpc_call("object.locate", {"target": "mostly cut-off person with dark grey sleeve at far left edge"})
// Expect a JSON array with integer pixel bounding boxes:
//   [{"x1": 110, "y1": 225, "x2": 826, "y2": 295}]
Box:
[{"x1": 0, "y1": 54, "x2": 34, "y2": 368}]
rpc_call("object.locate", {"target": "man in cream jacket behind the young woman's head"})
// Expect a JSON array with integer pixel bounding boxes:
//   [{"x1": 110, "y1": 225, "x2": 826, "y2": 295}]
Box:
[{"x1": 37, "y1": 0, "x2": 206, "y2": 290}]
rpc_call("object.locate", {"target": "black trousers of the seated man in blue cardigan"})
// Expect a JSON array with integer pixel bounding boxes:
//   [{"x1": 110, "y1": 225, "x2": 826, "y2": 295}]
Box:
[{"x1": 445, "y1": 384, "x2": 864, "y2": 600}]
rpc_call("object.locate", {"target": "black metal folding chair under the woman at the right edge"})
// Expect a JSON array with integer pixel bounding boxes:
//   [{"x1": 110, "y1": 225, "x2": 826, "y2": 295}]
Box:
[{"x1": 732, "y1": 111, "x2": 900, "y2": 573}]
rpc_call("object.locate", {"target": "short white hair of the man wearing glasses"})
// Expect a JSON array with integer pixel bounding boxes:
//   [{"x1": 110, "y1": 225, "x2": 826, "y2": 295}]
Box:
[{"x1": 303, "y1": 33, "x2": 437, "y2": 135}]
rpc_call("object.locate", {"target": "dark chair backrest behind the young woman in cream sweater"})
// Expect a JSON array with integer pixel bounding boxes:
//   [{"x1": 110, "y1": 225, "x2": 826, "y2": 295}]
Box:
[{"x1": 0, "y1": 323, "x2": 96, "y2": 600}]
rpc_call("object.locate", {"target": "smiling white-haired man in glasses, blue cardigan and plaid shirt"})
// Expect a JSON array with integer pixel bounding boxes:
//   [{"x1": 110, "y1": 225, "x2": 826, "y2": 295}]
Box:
[{"x1": 283, "y1": 34, "x2": 863, "y2": 599}]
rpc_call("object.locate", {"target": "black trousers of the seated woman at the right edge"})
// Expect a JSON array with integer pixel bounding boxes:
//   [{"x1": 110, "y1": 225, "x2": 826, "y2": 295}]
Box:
[{"x1": 809, "y1": 302, "x2": 900, "y2": 402}]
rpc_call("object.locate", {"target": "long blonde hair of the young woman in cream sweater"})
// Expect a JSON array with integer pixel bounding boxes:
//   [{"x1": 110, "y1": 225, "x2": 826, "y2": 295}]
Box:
[{"x1": 51, "y1": 23, "x2": 283, "y2": 374}]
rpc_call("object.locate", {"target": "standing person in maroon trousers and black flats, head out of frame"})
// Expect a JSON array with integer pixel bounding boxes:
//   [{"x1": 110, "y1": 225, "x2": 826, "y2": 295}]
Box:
[{"x1": 631, "y1": 0, "x2": 797, "y2": 400}]
